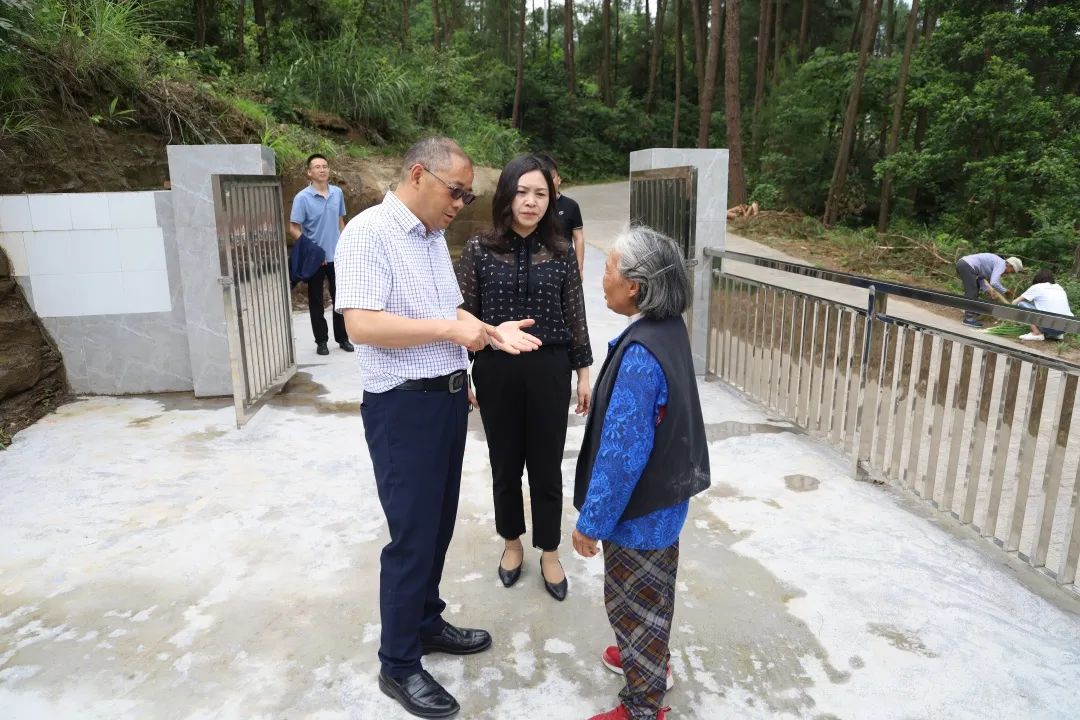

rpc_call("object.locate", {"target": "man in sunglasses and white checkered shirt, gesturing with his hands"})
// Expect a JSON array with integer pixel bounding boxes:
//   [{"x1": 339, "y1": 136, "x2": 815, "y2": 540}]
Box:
[{"x1": 336, "y1": 138, "x2": 540, "y2": 718}]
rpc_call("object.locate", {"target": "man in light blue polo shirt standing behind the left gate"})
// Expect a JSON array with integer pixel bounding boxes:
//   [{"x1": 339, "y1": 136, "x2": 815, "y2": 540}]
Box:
[{"x1": 288, "y1": 154, "x2": 355, "y2": 355}]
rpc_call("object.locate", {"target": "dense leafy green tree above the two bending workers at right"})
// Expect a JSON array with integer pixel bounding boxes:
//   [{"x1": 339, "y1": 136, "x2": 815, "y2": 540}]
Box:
[{"x1": 879, "y1": 3, "x2": 1080, "y2": 253}]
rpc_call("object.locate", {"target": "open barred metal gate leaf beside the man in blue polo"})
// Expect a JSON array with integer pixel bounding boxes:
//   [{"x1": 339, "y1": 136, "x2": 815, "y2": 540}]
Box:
[{"x1": 212, "y1": 175, "x2": 296, "y2": 427}]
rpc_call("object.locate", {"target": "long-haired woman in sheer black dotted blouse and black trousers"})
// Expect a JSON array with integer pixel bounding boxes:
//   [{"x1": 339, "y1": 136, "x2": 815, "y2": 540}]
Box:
[{"x1": 458, "y1": 155, "x2": 593, "y2": 600}]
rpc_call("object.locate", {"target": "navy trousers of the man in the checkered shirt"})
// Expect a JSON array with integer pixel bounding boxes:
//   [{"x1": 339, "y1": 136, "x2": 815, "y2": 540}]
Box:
[{"x1": 361, "y1": 390, "x2": 469, "y2": 679}]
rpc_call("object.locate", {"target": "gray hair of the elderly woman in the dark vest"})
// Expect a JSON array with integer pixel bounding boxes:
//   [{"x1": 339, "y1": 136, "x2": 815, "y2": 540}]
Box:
[{"x1": 611, "y1": 226, "x2": 690, "y2": 320}]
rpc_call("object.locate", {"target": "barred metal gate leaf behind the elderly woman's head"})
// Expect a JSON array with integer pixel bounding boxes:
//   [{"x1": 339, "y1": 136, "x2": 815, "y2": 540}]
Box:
[{"x1": 630, "y1": 165, "x2": 698, "y2": 338}]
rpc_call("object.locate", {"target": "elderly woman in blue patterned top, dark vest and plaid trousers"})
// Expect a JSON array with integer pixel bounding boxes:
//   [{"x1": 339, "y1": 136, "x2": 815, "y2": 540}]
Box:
[{"x1": 573, "y1": 227, "x2": 710, "y2": 720}]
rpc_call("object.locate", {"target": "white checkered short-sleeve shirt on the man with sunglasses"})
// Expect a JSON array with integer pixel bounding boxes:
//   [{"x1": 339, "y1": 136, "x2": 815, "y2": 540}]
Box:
[{"x1": 334, "y1": 192, "x2": 468, "y2": 393}]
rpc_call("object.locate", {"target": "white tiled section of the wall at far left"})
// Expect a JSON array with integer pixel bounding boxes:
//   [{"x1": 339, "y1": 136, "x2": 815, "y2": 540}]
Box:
[{"x1": 0, "y1": 192, "x2": 172, "y2": 317}]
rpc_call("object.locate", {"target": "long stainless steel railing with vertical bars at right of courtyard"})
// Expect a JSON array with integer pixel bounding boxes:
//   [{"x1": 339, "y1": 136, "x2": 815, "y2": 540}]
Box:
[{"x1": 706, "y1": 250, "x2": 1080, "y2": 590}]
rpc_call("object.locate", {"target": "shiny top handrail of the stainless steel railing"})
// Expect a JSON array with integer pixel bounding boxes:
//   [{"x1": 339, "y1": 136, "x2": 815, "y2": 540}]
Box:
[{"x1": 704, "y1": 247, "x2": 1080, "y2": 332}]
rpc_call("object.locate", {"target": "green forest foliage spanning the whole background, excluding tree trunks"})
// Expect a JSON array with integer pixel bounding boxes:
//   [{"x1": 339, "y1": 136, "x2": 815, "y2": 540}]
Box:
[{"x1": 0, "y1": 0, "x2": 1080, "y2": 289}]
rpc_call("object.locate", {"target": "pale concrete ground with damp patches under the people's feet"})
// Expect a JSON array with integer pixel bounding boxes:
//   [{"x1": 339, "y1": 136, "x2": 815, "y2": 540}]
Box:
[{"x1": 6, "y1": 188, "x2": 1080, "y2": 720}]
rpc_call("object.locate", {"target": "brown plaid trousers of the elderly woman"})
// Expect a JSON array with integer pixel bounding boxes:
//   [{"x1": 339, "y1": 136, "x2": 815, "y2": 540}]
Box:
[{"x1": 604, "y1": 541, "x2": 678, "y2": 720}]
